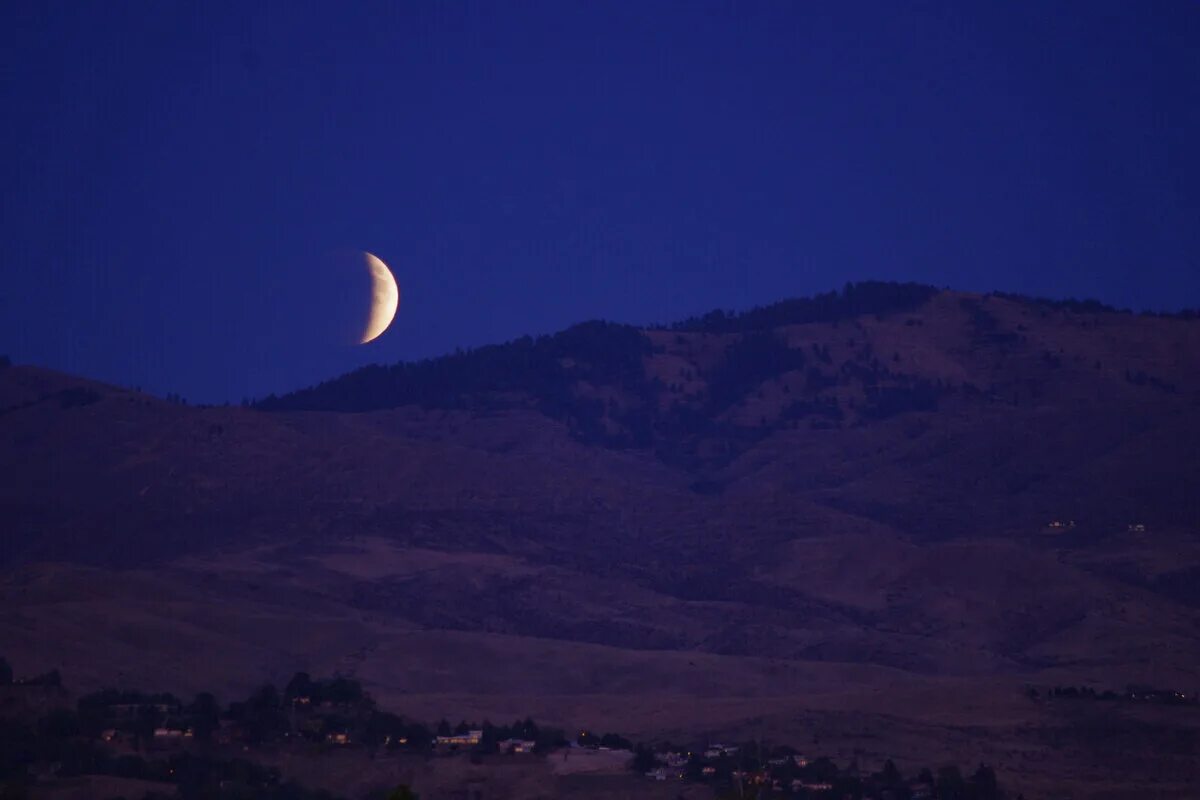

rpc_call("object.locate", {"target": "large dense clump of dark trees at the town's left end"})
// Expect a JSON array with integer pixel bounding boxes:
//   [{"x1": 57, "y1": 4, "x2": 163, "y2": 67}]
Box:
[{"x1": 0, "y1": 657, "x2": 441, "y2": 800}]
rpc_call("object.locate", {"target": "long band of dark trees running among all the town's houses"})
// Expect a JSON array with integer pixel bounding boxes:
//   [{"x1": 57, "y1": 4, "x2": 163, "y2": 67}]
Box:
[{"x1": 0, "y1": 657, "x2": 1017, "y2": 800}]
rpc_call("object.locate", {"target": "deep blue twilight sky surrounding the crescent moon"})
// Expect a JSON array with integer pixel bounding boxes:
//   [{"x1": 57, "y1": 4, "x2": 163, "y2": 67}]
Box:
[{"x1": 0, "y1": 0, "x2": 1200, "y2": 402}]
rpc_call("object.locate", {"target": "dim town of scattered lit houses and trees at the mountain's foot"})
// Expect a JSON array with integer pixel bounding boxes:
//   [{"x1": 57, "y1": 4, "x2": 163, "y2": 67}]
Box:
[{"x1": 0, "y1": 658, "x2": 1008, "y2": 800}]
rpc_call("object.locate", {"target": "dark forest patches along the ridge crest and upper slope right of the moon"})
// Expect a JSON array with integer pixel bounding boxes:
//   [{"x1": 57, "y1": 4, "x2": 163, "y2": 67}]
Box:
[{"x1": 243, "y1": 282, "x2": 974, "y2": 463}]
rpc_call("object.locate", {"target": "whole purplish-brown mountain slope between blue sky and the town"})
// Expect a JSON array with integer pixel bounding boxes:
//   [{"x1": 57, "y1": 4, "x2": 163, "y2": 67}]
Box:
[{"x1": 0, "y1": 283, "x2": 1200, "y2": 796}]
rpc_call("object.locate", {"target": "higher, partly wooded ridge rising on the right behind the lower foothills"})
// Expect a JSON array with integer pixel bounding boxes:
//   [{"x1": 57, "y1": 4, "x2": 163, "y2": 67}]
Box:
[{"x1": 258, "y1": 284, "x2": 1200, "y2": 535}]
